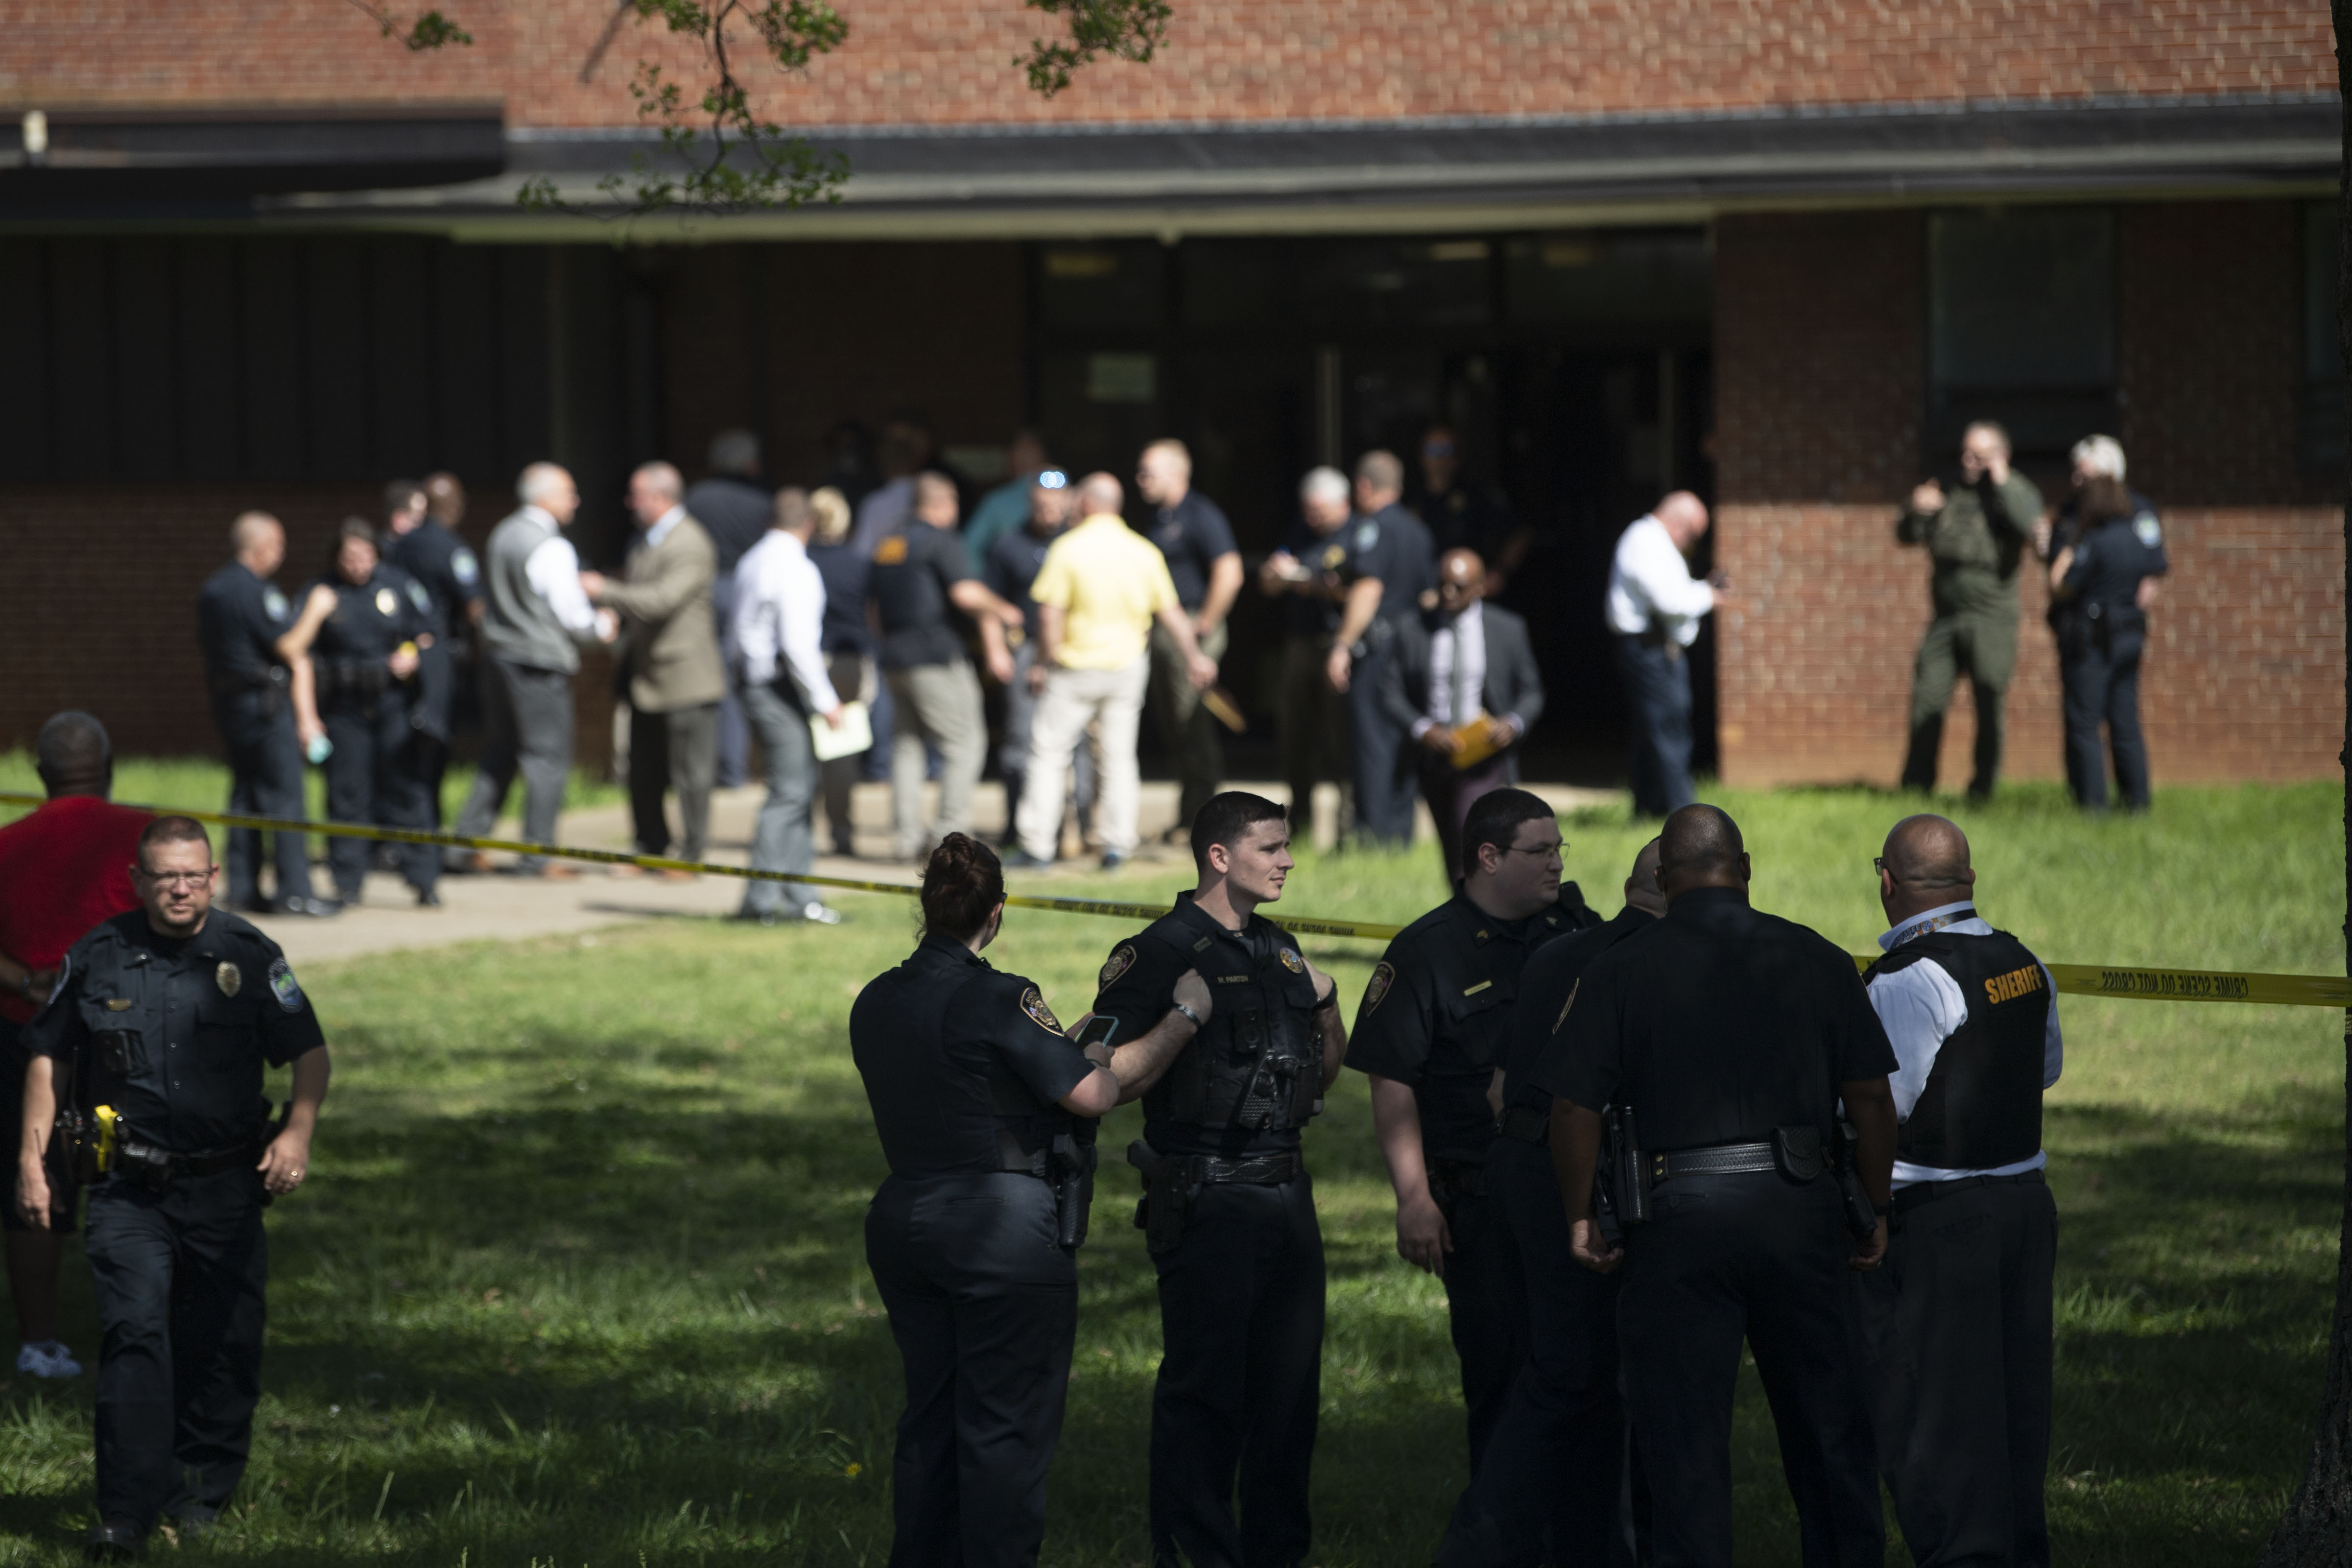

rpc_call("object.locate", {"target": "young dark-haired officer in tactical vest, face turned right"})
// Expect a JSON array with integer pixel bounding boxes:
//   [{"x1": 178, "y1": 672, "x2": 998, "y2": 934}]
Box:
[{"x1": 1093, "y1": 790, "x2": 1348, "y2": 1568}]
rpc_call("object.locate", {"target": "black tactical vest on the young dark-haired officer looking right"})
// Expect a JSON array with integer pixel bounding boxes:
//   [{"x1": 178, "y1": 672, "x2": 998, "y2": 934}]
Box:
[{"x1": 1143, "y1": 919, "x2": 1324, "y2": 1133}]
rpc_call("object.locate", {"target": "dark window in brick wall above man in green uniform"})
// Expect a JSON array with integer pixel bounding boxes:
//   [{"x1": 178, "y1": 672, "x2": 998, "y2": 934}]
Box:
[{"x1": 1926, "y1": 207, "x2": 2114, "y2": 463}]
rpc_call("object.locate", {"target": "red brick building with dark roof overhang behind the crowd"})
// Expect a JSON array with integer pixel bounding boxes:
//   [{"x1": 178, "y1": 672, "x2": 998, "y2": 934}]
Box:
[{"x1": 0, "y1": 0, "x2": 2345, "y2": 783}]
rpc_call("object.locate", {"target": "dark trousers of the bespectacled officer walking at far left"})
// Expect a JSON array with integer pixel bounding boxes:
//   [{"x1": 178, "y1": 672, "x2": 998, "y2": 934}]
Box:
[{"x1": 82, "y1": 1166, "x2": 270, "y2": 1528}]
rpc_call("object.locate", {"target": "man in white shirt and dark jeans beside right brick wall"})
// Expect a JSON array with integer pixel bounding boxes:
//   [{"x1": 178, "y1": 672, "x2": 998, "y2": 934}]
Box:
[{"x1": 1609, "y1": 489, "x2": 1722, "y2": 816}]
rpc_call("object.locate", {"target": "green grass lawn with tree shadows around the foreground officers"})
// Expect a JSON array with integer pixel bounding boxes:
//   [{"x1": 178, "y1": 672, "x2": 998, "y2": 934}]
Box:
[{"x1": 0, "y1": 769, "x2": 2345, "y2": 1568}]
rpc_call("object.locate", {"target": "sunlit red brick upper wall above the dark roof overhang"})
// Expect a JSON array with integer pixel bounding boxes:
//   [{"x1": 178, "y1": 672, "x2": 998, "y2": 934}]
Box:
[{"x1": 0, "y1": 0, "x2": 2335, "y2": 124}]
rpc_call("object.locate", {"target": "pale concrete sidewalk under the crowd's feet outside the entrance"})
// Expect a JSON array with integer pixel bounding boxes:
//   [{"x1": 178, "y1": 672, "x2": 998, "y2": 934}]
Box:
[{"x1": 261, "y1": 783, "x2": 1625, "y2": 964}]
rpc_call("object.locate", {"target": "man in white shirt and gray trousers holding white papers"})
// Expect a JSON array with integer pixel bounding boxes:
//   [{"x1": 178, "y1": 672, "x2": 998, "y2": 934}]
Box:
[{"x1": 727, "y1": 487, "x2": 842, "y2": 926}]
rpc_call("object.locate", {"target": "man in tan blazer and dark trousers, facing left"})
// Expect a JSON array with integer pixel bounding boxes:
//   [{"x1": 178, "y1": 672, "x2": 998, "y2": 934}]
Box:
[{"x1": 581, "y1": 463, "x2": 727, "y2": 877}]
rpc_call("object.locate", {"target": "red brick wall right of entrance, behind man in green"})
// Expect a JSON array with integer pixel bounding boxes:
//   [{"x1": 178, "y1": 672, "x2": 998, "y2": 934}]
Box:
[{"x1": 1714, "y1": 202, "x2": 2345, "y2": 785}]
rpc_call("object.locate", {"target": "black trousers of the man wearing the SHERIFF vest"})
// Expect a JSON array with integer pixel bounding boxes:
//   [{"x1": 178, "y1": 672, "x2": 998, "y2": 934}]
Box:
[{"x1": 1858, "y1": 1175, "x2": 2058, "y2": 1568}]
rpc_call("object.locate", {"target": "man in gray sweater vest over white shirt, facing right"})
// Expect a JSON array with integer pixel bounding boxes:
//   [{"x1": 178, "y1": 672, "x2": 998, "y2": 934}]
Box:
[{"x1": 451, "y1": 463, "x2": 618, "y2": 879}]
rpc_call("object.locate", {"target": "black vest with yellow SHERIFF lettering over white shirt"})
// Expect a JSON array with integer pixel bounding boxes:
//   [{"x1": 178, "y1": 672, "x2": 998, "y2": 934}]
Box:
[{"x1": 1865, "y1": 931, "x2": 2053, "y2": 1171}]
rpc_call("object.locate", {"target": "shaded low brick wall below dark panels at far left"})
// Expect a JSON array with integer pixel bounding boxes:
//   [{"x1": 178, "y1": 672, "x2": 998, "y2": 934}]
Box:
[{"x1": 0, "y1": 484, "x2": 612, "y2": 766}]
